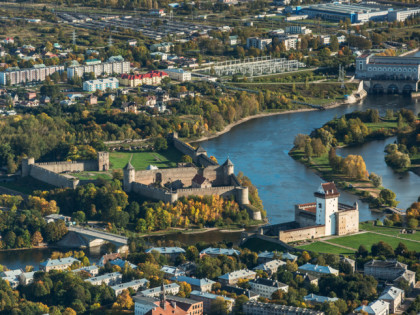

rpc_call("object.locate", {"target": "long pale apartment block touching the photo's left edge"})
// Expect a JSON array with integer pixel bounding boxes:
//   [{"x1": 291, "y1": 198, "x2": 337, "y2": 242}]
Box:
[{"x1": 0, "y1": 64, "x2": 64, "y2": 85}]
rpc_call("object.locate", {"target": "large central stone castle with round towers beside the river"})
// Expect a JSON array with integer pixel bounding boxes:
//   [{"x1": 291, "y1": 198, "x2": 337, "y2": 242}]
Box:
[{"x1": 123, "y1": 133, "x2": 261, "y2": 220}]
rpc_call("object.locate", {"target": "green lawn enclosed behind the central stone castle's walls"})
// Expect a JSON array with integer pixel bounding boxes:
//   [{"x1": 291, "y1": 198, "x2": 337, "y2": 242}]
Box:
[{"x1": 109, "y1": 148, "x2": 182, "y2": 170}]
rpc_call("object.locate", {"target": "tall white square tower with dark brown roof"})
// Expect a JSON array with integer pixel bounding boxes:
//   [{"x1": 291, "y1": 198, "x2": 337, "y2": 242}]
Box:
[{"x1": 314, "y1": 182, "x2": 340, "y2": 236}]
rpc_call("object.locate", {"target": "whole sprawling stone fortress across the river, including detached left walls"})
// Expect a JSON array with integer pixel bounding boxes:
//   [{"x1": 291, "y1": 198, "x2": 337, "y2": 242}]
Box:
[{"x1": 22, "y1": 133, "x2": 261, "y2": 220}]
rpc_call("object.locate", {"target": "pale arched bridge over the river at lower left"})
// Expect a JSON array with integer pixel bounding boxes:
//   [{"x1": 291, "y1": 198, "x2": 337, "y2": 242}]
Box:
[{"x1": 68, "y1": 226, "x2": 128, "y2": 252}]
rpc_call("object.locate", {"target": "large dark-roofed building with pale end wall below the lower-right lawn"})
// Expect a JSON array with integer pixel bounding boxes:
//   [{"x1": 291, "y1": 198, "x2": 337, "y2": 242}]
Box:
[{"x1": 364, "y1": 259, "x2": 416, "y2": 286}]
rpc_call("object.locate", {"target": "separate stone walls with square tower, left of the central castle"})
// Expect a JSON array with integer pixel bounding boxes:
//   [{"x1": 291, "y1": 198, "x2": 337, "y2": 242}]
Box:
[{"x1": 22, "y1": 152, "x2": 109, "y2": 189}]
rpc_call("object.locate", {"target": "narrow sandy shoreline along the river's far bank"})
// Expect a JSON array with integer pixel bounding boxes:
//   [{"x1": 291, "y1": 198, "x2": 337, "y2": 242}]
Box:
[{"x1": 189, "y1": 91, "x2": 367, "y2": 143}]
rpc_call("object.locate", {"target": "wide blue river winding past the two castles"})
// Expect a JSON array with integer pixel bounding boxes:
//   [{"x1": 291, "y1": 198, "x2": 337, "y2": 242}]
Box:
[{"x1": 0, "y1": 95, "x2": 420, "y2": 269}]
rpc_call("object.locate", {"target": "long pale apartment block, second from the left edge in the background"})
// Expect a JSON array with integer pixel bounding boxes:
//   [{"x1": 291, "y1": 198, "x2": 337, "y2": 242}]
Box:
[{"x1": 67, "y1": 61, "x2": 130, "y2": 79}]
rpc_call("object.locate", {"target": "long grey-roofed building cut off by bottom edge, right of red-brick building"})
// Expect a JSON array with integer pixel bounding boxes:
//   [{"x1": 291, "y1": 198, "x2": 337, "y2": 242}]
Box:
[{"x1": 243, "y1": 301, "x2": 325, "y2": 315}]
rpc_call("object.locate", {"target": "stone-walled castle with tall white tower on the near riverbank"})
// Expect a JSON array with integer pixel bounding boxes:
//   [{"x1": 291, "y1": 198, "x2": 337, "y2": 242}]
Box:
[{"x1": 259, "y1": 182, "x2": 359, "y2": 243}]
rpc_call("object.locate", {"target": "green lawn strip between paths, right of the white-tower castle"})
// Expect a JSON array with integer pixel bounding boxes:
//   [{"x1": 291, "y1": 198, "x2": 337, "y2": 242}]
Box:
[{"x1": 328, "y1": 232, "x2": 420, "y2": 251}]
